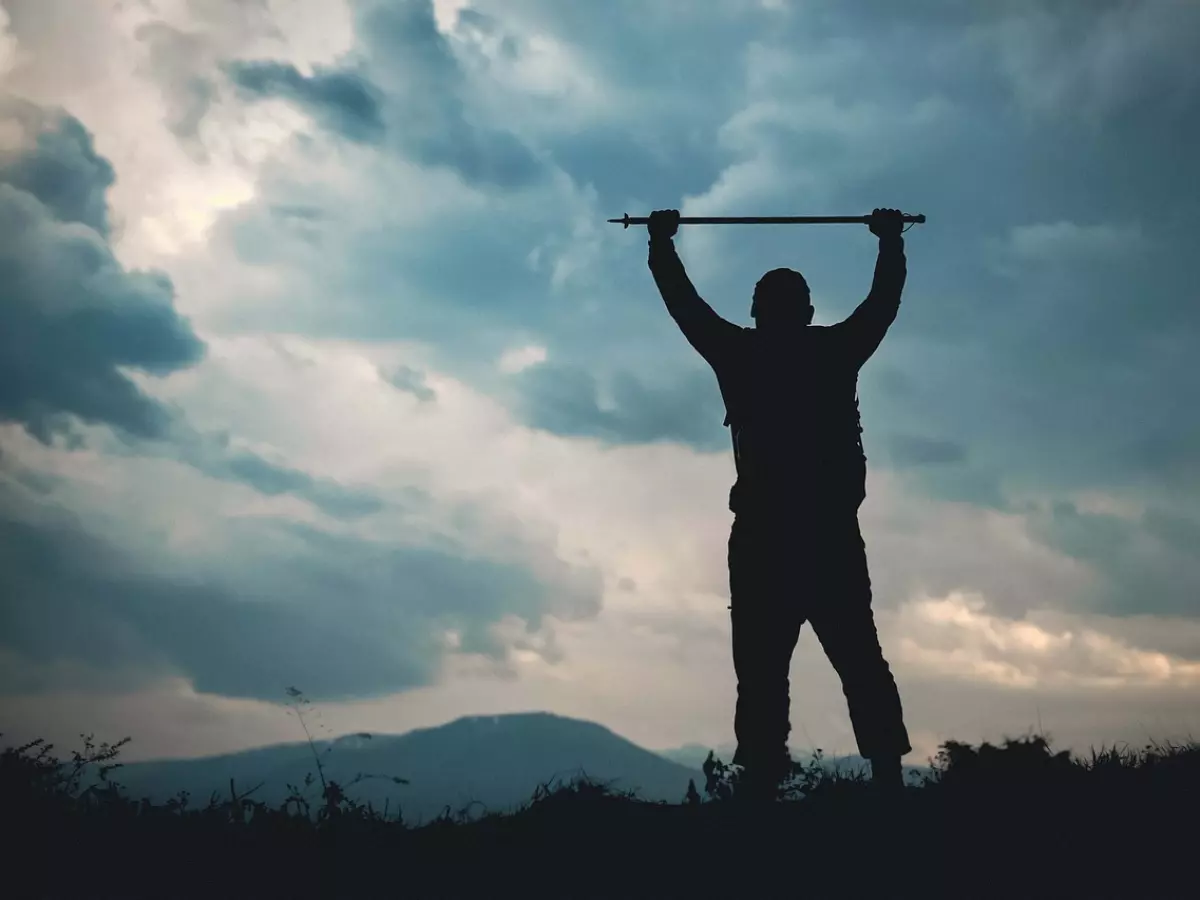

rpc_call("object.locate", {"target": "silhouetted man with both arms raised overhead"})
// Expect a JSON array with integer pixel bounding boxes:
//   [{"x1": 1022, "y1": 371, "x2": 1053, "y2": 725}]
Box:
[{"x1": 648, "y1": 209, "x2": 912, "y2": 792}]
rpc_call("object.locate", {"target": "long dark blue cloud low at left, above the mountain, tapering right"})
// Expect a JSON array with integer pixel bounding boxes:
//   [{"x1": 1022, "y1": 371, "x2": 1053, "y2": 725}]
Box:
[{"x1": 0, "y1": 504, "x2": 432, "y2": 700}]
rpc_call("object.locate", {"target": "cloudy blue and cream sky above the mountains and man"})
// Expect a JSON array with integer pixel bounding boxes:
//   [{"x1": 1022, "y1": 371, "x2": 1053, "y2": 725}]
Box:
[{"x1": 0, "y1": 0, "x2": 1200, "y2": 763}]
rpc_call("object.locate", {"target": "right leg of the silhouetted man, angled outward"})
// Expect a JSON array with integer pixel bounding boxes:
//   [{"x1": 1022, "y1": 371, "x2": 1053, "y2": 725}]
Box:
[{"x1": 808, "y1": 515, "x2": 912, "y2": 785}]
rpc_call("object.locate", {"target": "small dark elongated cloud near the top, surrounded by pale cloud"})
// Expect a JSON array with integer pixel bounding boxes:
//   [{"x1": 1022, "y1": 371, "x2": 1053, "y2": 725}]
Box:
[{"x1": 226, "y1": 61, "x2": 384, "y2": 143}]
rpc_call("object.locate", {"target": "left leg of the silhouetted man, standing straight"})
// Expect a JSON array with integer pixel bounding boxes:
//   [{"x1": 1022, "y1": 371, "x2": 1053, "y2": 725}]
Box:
[{"x1": 730, "y1": 518, "x2": 804, "y2": 791}]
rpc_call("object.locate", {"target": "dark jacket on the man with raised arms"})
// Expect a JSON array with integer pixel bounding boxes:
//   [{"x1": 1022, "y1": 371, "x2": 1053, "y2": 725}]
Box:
[{"x1": 649, "y1": 238, "x2": 907, "y2": 514}]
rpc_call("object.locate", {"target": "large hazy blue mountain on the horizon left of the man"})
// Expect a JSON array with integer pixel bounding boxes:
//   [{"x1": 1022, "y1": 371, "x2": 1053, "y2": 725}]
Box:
[{"x1": 105, "y1": 713, "x2": 707, "y2": 823}]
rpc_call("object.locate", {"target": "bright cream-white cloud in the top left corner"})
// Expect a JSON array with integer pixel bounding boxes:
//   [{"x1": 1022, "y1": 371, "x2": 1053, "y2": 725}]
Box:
[{"x1": 5, "y1": 0, "x2": 353, "y2": 264}]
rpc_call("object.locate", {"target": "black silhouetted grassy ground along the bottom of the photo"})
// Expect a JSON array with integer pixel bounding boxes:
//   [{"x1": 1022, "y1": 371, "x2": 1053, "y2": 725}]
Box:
[{"x1": 0, "y1": 738, "x2": 1200, "y2": 898}]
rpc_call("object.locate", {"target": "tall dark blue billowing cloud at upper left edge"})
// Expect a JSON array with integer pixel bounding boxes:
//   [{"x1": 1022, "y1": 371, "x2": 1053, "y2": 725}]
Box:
[{"x1": 0, "y1": 98, "x2": 204, "y2": 442}]
